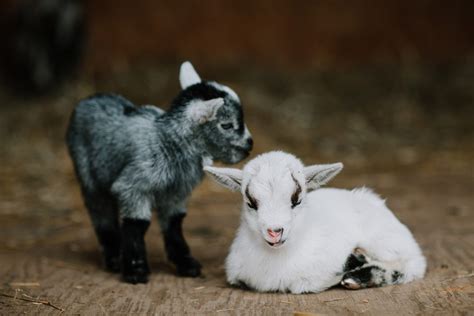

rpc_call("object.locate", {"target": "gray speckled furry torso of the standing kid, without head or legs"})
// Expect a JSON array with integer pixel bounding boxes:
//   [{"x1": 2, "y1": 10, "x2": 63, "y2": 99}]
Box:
[{"x1": 67, "y1": 90, "x2": 252, "y2": 219}]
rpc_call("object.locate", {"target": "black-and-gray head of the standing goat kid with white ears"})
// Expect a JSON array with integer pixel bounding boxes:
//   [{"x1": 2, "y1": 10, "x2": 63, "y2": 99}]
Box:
[{"x1": 172, "y1": 62, "x2": 253, "y2": 163}]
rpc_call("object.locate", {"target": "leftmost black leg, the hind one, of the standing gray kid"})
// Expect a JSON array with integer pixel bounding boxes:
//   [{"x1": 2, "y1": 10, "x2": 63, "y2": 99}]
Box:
[{"x1": 84, "y1": 193, "x2": 121, "y2": 272}]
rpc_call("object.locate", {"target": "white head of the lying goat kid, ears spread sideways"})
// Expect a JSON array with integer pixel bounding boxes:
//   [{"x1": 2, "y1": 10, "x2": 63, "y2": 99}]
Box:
[{"x1": 204, "y1": 151, "x2": 343, "y2": 248}]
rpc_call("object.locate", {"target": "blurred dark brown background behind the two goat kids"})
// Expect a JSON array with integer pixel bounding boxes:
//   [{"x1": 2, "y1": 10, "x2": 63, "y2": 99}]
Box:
[{"x1": 0, "y1": 0, "x2": 474, "y2": 314}]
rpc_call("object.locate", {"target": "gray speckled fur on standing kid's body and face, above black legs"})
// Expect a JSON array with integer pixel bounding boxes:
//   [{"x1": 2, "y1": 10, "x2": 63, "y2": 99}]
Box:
[{"x1": 67, "y1": 62, "x2": 252, "y2": 282}]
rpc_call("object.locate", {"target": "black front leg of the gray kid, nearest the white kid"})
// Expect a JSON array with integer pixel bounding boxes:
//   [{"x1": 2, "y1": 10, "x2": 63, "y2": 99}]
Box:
[{"x1": 160, "y1": 213, "x2": 201, "y2": 277}]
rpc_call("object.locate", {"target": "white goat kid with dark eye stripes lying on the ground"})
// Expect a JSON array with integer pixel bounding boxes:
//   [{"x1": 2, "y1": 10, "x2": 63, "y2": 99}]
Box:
[{"x1": 204, "y1": 152, "x2": 426, "y2": 293}]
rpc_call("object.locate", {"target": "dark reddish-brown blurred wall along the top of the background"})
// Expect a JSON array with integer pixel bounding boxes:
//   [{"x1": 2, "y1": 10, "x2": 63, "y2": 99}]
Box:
[{"x1": 0, "y1": 0, "x2": 474, "y2": 71}]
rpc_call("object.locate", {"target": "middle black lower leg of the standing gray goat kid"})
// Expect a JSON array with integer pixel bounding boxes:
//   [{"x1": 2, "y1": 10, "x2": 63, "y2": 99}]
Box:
[{"x1": 122, "y1": 218, "x2": 150, "y2": 284}]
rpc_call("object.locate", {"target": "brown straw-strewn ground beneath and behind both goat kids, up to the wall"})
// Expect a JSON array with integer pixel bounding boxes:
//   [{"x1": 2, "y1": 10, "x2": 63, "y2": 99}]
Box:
[{"x1": 0, "y1": 61, "x2": 474, "y2": 315}]
